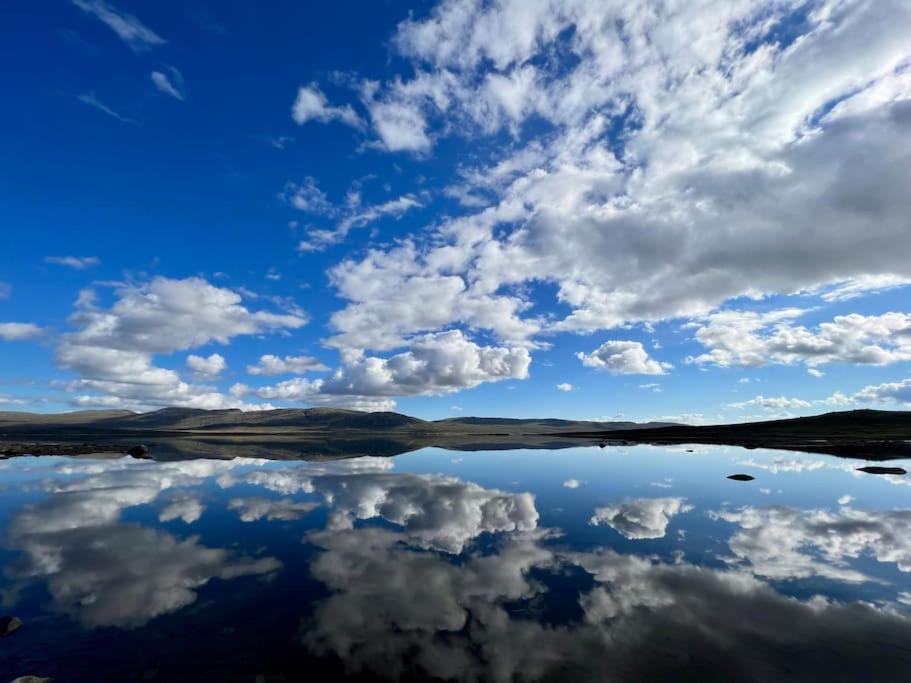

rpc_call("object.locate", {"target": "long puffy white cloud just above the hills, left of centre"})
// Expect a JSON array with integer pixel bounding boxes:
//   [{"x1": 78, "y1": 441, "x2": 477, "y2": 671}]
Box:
[{"x1": 255, "y1": 330, "x2": 531, "y2": 412}]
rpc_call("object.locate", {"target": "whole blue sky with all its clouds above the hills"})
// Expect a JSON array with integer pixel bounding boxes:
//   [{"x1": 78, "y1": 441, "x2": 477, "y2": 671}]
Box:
[{"x1": 0, "y1": 0, "x2": 911, "y2": 422}]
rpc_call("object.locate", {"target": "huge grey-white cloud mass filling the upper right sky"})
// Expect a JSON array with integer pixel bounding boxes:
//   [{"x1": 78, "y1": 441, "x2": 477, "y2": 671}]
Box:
[{"x1": 308, "y1": 0, "x2": 911, "y2": 362}]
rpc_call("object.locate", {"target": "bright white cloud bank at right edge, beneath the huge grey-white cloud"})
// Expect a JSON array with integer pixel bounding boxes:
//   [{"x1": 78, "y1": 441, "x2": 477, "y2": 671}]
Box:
[{"x1": 688, "y1": 309, "x2": 911, "y2": 376}]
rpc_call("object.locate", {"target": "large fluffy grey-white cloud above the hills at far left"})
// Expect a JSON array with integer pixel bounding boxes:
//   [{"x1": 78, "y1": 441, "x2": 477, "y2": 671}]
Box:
[{"x1": 57, "y1": 277, "x2": 307, "y2": 409}]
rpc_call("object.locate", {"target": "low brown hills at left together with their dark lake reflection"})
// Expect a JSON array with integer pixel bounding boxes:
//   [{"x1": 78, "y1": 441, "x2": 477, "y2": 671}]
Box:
[{"x1": 0, "y1": 408, "x2": 667, "y2": 460}]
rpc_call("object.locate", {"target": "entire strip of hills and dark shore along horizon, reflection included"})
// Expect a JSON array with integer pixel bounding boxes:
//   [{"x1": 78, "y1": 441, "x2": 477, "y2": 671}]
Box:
[{"x1": 0, "y1": 408, "x2": 911, "y2": 460}]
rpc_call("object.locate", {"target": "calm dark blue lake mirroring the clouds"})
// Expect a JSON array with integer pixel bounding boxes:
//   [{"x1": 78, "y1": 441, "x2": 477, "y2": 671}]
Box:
[{"x1": 0, "y1": 446, "x2": 911, "y2": 682}]
